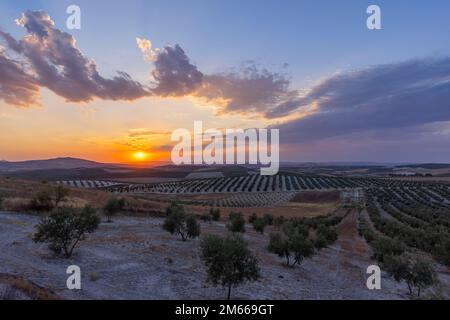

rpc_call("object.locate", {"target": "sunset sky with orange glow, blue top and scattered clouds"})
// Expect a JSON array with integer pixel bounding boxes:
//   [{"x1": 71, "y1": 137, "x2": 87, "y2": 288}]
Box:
[{"x1": 0, "y1": 0, "x2": 450, "y2": 162}]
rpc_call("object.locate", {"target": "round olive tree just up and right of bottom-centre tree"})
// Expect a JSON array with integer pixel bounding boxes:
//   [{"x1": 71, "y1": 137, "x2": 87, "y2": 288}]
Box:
[{"x1": 267, "y1": 223, "x2": 314, "y2": 267}]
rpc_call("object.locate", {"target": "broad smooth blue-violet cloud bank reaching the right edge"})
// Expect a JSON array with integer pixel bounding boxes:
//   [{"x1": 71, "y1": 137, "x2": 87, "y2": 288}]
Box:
[{"x1": 280, "y1": 58, "x2": 450, "y2": 142}]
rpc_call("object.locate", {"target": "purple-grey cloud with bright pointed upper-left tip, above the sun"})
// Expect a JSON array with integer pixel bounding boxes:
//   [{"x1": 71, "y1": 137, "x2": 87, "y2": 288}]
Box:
[{"x1": 136, "y1": 38, "x2": 298, "y2": 117}]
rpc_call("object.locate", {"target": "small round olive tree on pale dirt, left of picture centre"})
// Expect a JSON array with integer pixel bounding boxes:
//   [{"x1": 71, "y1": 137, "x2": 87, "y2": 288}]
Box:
[{"x1": 163, "y1": 204, "x2": 200, "y2": 241}]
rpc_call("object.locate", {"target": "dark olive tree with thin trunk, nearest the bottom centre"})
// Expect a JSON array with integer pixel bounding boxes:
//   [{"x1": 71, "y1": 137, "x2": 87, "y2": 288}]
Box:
[{"x1": 200, "y1": 234, "x2": 260, "y2": 300}]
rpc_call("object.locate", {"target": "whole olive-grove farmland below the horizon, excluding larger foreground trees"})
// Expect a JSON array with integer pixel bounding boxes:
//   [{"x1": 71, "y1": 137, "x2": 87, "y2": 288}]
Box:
[{"x1": 0, "y1": 174, "x2": 450, "y2": 299}]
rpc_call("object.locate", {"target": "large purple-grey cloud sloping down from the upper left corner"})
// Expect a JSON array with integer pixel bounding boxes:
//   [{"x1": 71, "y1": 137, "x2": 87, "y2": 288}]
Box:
[{"x1": 0, "y1": 11, "x2": 150, "y2": 106}]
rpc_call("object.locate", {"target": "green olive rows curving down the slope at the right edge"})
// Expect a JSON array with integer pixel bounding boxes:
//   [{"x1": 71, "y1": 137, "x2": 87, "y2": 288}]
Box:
[{"x1": 360, "y1": 184, "x2": 450, "y2": 266}]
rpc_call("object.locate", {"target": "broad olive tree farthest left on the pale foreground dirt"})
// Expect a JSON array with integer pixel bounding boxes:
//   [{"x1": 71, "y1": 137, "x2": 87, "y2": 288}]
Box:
[{"x1": 33, "y1": 206, "x2": 100, "y2": 258}]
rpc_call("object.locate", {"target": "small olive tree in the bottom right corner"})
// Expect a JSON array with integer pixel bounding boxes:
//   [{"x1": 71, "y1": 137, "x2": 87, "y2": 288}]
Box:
[{"x1": 384, "y1": 254, "x2": 437, "y2": 297}]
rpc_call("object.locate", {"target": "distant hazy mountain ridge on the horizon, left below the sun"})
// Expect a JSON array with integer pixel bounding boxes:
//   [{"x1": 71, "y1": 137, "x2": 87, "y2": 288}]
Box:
[{"x1": 0, "y1": 157, "x2": 110, "y2": 171}]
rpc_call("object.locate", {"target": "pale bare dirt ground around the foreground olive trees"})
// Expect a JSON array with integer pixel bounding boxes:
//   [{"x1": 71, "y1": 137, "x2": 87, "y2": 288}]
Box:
[{"x1": 0, "y1": 212, "x2": 444, "y2": 299}]
